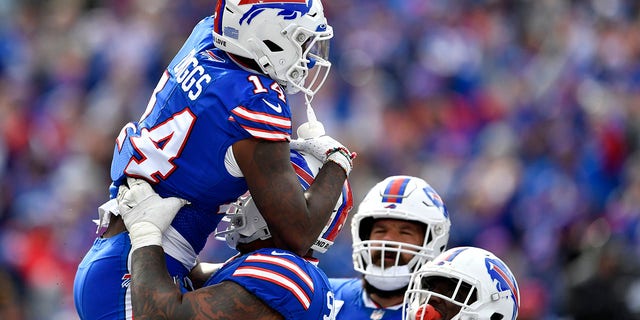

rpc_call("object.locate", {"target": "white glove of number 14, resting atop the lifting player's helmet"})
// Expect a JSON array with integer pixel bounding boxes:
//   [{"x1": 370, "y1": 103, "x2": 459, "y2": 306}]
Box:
[{"x1": 289, "y1": 136, "x2": 356, "y2": 176}]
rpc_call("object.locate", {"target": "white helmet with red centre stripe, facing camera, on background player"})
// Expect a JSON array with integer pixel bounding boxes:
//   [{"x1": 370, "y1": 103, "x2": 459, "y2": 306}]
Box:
[{"x1": 351, "y1": 175, "x2": 451, "y2": 291}]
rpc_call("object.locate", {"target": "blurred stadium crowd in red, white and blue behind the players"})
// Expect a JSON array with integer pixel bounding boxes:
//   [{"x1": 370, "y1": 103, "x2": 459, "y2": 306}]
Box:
[{"x1": 0, "y1": 0, "x2": 640, "y2": 320}]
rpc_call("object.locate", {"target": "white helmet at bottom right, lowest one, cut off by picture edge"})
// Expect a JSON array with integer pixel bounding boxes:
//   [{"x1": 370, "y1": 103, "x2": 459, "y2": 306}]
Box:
[{"x1": 403, "y1": 247, "x2": 520, "y2": 320}]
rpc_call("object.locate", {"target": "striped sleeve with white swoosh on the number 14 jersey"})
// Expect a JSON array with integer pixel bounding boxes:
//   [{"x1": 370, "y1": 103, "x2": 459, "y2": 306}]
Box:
[{"x1": 230, "y1": 86, "x2": 291, "y2": 141}]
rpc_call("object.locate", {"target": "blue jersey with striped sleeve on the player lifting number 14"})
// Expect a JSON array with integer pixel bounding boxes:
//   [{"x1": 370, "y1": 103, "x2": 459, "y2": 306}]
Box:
[{"x1": 205, "y1": 248, "x2": 335, "y2": 320}]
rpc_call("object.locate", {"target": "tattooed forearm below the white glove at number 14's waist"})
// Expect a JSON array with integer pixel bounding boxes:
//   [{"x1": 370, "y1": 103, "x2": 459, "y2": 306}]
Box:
[{"x1": 131, "y1": 246, "x2": 182, "y2": 319}]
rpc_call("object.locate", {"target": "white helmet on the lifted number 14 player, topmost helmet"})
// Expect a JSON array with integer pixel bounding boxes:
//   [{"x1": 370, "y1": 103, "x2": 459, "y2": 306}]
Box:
[{"x1": 213, "y1": 0, "x2": 333, "y2": 100}]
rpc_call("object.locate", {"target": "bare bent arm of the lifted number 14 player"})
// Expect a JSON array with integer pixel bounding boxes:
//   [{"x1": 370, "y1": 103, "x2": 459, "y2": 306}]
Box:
[{"x1": 241, "y1": 140, "x2": 347, "y2": 255}]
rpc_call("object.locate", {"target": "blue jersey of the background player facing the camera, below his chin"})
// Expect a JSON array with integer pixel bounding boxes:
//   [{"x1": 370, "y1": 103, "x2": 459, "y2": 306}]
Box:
[{"x1": 329, "y1": 278, "x2": 402, "y2": 320}]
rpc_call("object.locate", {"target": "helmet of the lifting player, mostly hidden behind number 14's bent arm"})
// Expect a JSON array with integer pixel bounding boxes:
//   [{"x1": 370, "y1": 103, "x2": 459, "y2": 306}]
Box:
[{"x1": 215, "y1": 149, "x2": 353, "y2": 253}]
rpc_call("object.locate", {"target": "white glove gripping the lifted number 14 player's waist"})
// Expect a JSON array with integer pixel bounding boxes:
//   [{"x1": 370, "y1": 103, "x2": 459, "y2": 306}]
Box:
[{"x1": 117, "y1": 178, "x2": 189, "y2": 251}]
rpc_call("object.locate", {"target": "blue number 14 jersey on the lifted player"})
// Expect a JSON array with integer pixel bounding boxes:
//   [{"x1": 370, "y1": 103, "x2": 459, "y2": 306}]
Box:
[{"x1": 110, "y1": 17, "x2": 291, "y2": 275}]
